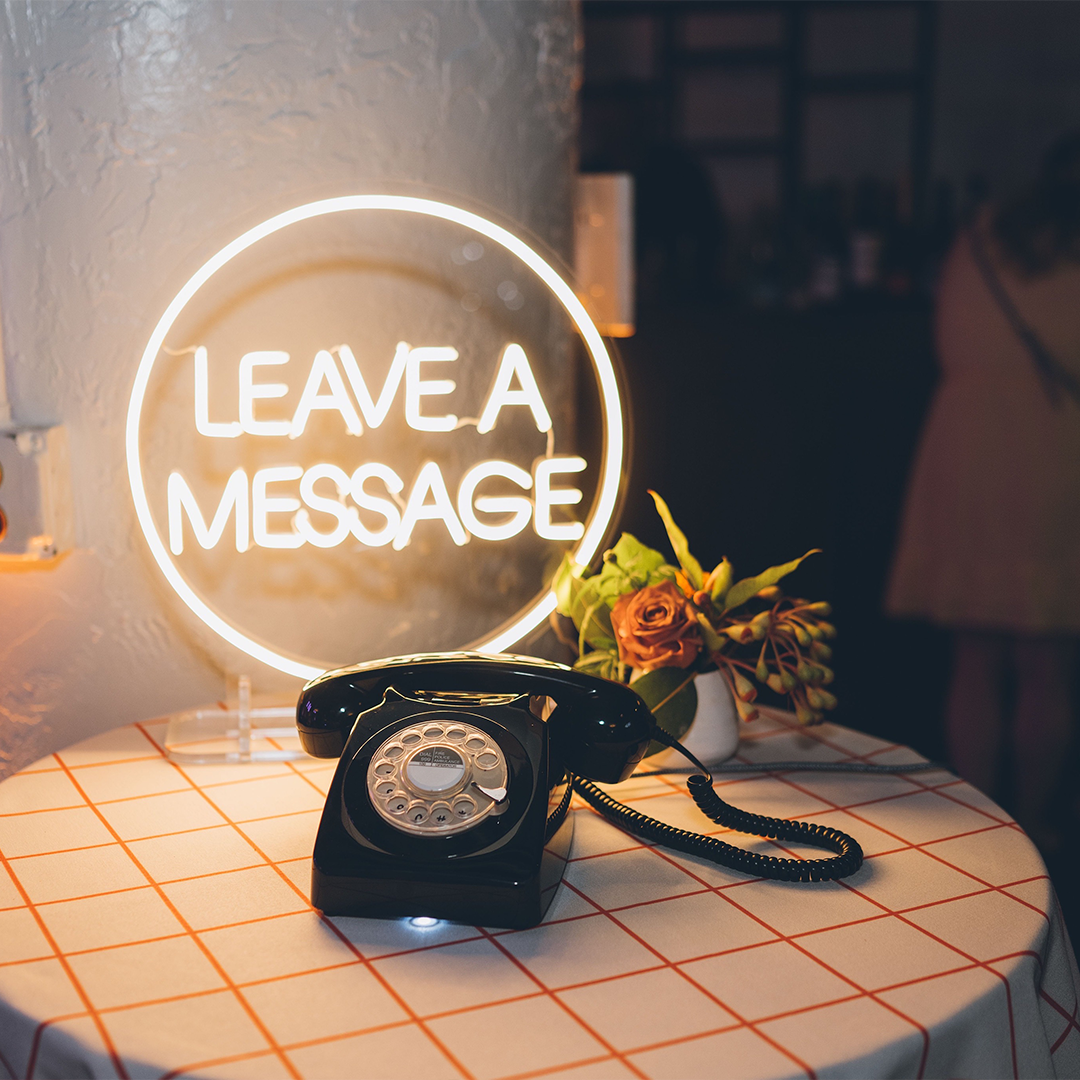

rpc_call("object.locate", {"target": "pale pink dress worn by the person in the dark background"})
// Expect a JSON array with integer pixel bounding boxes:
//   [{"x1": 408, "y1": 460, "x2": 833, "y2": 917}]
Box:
[{"x1": 886, "y1": 225, "x2": 1080, "y2": 634}]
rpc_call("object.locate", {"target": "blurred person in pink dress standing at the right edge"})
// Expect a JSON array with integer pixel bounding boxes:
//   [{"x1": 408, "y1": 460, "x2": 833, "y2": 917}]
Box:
[{"x1": 886, "y1": 133, "x2": 1080, "y2": 847}]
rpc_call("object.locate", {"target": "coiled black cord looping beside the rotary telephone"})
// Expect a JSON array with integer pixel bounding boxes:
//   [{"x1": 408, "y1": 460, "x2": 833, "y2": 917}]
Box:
[{"x1": 572, "y1": 728, "x2": 863, "y2": 881}]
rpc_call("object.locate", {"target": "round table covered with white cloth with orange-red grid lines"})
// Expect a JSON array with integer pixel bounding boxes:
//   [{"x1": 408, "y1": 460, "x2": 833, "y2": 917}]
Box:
[{"x1": 0, "y1": 714, "x2": 1080, "y2": 1080}]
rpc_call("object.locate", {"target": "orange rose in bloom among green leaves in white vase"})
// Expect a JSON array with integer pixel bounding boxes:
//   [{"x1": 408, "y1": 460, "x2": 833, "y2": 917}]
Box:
[{"x1": 611, "y1": 581, "x2": 701, "y2": 672}]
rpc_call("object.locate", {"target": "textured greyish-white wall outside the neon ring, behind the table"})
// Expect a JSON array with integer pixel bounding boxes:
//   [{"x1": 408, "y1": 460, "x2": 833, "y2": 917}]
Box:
[{"x1": 0, "y1": 0, "x2": 579, "y2": 773}]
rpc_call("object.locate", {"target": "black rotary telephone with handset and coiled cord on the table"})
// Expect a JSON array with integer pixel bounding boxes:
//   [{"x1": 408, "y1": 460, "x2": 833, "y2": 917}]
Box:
[{"x1": 296, "y1": 652, "x2": 862, "y2": 928}]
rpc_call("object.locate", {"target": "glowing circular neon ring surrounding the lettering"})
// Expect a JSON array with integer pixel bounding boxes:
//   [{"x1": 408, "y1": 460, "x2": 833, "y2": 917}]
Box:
[{"x1": 125, "y1": 195, "x2": 623, "y2": 679}]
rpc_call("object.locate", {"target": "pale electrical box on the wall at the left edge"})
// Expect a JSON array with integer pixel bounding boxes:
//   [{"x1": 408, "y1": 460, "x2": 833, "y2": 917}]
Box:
[{"x1": 0, "y1": 428, "x2": 75, "y2": 568}]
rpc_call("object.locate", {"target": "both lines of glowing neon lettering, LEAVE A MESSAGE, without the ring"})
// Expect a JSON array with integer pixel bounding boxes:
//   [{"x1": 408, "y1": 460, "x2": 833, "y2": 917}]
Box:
[{"x1": 167, "y1": 341, "x2": 588, "y2": 555}]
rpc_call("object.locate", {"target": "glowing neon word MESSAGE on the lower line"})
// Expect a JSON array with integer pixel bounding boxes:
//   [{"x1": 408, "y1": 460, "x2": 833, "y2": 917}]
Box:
[{"x1": 168, "y1": 456, "x2": 586, "y2": 555}]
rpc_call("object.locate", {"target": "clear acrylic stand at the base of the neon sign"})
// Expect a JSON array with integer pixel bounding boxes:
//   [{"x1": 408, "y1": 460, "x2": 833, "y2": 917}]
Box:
[{"x1": 165, "y1": 675, "x2": 307, "y2": 765}]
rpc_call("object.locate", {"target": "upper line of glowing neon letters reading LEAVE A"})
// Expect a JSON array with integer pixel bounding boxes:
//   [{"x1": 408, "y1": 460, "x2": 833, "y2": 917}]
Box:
[{"x1": 195, "y1": 341, "x2": 551, "y2": 438}]
